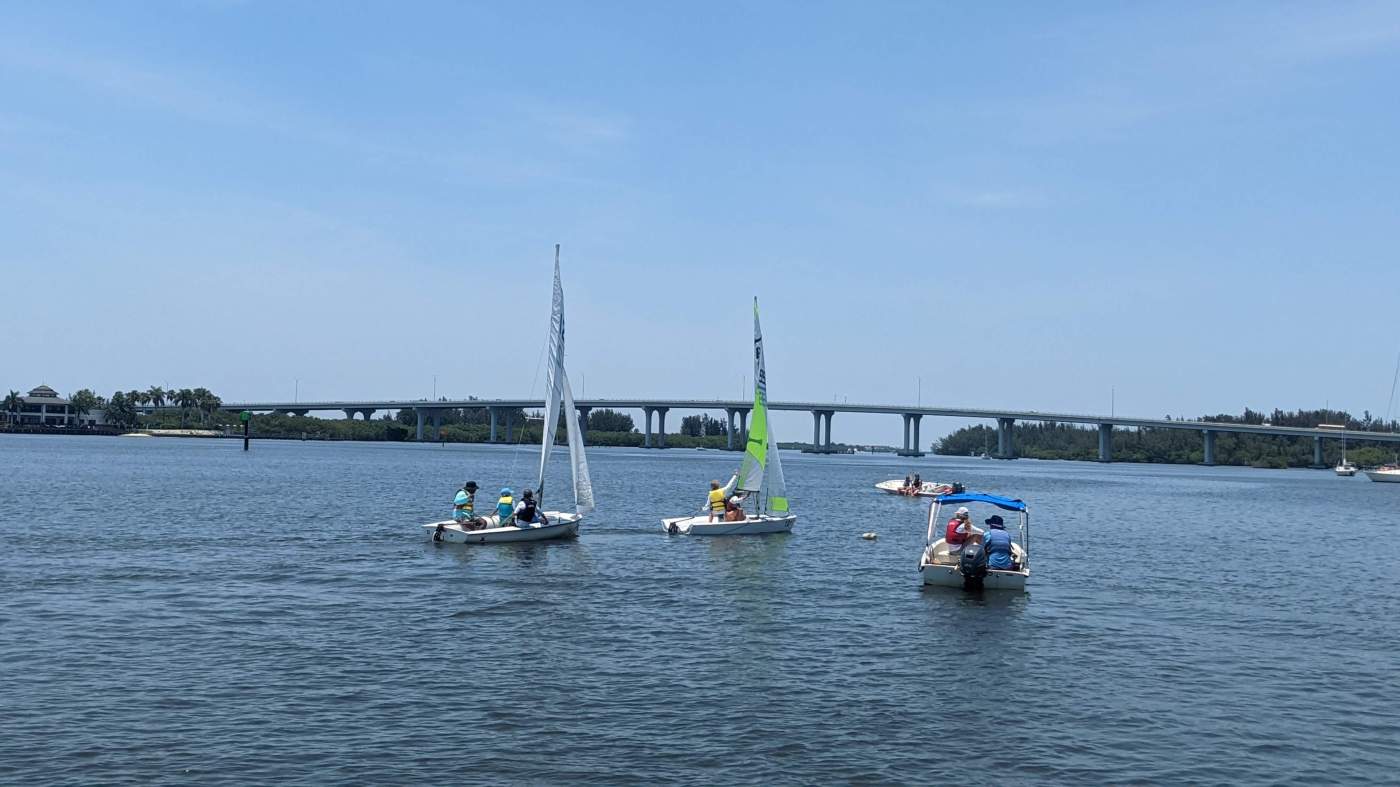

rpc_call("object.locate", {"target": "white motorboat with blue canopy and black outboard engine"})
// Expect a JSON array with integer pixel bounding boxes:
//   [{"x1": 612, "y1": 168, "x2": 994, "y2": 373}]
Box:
[{"x1": 918, "y1": 492, "x2": 1030, "y2": 591}]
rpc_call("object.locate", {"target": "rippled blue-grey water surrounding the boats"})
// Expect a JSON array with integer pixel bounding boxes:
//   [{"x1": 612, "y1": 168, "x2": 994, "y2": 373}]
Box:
[{"x1": 0, "y1": 437, "x2": 1400, "y2": 784}]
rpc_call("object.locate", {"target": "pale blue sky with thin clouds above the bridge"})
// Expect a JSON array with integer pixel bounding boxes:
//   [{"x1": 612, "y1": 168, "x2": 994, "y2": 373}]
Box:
[{"x1": 0, "y1": 0, "x2": 1400, "y2": 443}]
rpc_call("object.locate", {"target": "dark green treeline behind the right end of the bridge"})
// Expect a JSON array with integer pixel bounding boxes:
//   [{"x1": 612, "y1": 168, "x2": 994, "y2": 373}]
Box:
[{"x1": 934, "y1": 409, "x2": 1400, "y2": 468}]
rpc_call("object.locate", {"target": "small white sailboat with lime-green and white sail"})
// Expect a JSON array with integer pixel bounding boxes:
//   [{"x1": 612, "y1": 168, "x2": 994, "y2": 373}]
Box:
[{"x1": 661, "y1": 298, "x2": 797, "y2": 535}]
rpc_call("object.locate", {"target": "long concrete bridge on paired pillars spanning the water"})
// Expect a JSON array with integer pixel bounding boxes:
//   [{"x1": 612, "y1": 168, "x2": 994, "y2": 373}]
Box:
[{"x1": 200, "y1": 399, "x2": 1400, "y2": 466}]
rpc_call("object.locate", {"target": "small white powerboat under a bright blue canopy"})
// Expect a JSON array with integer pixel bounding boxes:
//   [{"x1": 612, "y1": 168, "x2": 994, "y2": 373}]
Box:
[{"x1": 918, "y1": 492, "x2": 1030, "y2": 591}]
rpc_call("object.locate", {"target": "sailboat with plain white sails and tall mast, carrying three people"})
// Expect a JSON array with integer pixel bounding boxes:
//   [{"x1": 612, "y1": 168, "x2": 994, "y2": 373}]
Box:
[{"x1": 423, "y1": 245, "x2": 594, "y2": 543}]
